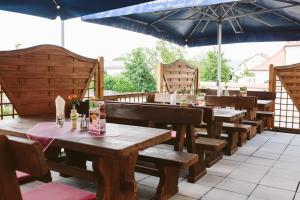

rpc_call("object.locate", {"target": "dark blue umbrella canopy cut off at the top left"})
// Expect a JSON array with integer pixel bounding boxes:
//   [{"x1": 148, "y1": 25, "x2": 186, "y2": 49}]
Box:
[{"x1": 0, "y1": 0, "x2": 152, "y2": 20}]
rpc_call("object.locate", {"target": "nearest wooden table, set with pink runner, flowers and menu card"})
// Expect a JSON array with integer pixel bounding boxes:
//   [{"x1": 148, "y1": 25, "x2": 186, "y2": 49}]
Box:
[{"x1": 0, "y1": 118, "x2": 171, "y2": 200}]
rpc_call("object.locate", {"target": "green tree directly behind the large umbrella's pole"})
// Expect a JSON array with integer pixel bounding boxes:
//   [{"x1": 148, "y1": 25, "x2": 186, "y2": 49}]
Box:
[{"x1": 200, "y1": 50, "x2": 232, "y2": 81}]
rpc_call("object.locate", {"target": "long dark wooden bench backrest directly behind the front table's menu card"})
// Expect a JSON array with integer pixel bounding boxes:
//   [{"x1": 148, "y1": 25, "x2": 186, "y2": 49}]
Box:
[{"x1": 105, "y1": 101, "x2": 203, "y2": 124}]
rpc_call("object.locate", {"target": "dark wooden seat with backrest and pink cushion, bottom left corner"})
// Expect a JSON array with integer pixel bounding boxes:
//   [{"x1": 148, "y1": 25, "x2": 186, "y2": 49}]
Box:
[{"x1": 0, "y1": 135, "x2": 96, "y2": 200}]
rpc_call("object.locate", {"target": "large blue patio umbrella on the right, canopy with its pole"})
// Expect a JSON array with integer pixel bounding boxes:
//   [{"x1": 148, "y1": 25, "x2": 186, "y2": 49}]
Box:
[{"x1": 82, "y1": 0, "x2": 300, "y2": 95}]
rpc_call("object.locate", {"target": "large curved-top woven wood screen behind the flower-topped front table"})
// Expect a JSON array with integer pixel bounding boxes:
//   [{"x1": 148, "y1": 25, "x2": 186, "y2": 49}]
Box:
[{"x1": 0, "y1": 45, "x2": 100, "y2": 117}]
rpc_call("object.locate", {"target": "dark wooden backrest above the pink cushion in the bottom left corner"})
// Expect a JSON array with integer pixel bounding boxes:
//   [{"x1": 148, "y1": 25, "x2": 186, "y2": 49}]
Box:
[{"x1": 0, "y1": 135, "x2": 49, "y2": 200}]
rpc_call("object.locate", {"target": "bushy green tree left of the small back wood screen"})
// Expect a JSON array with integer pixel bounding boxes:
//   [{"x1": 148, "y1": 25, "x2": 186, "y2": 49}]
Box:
[{"x1": 124, "y1": 48, "x2": 156, "y2": 92}]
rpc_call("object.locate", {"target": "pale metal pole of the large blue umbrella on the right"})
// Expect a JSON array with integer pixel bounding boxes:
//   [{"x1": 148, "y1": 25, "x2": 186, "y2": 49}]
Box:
[{"x1": 217, "y1": 20, "x2": 222, "y2": 96}]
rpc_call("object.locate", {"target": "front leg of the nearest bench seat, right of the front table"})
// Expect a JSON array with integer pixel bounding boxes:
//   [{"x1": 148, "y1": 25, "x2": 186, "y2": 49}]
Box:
[{"x1": 154, "y1": 165, "x2": 180, "y2": 200}]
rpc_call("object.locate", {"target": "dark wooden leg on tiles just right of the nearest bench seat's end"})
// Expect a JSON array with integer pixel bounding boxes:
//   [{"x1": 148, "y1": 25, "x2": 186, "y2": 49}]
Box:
[{"x1": 188, "y1": 148, "x2": 206, "y2": 183}]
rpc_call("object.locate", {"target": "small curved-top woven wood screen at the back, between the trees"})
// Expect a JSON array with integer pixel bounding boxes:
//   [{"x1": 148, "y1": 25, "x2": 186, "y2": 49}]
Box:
[{"x1": 157, "y1": 60, "x2": 198, "y2": 94}]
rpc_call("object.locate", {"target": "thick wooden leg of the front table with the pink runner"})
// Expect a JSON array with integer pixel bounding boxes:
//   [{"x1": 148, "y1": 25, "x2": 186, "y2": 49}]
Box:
[{"x1": 93, "y1": 152, "x2": 138, "y2": 200}]
